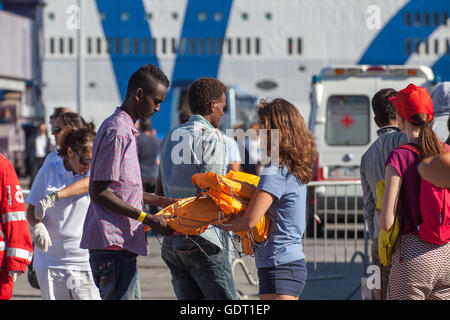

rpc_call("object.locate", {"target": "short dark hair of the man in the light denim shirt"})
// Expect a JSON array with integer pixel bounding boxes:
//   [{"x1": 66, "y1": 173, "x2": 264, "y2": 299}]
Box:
[{"x1": 188, "y1": 77, "x2": 227, "y2": 115}]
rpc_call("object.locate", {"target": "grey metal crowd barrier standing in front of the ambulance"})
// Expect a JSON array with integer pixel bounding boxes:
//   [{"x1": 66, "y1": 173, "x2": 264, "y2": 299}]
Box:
[{"x1": 231, "y1": 181, "x2": 369, "y2": 299}]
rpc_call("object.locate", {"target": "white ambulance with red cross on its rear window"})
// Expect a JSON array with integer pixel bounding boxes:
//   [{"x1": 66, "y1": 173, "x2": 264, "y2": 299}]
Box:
[{"x1": 307, "y1": 65, "x2": 435, "y2": 237}]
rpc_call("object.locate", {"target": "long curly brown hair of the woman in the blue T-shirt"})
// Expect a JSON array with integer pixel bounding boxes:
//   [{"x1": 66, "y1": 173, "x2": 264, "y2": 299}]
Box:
[{"x1": 257, "y1": 98, "x2": 317, "y2": 184}]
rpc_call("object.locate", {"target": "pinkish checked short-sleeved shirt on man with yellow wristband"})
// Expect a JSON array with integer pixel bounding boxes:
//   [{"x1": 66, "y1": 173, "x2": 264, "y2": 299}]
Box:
[{"x1": 80, "y1": 108, "x2": 148, "y2": 255}]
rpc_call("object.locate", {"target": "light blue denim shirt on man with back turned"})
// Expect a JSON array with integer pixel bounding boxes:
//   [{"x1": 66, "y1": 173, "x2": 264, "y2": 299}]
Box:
[{"x1": 158, "y1": 114, "x2": 226, "y2": 249}]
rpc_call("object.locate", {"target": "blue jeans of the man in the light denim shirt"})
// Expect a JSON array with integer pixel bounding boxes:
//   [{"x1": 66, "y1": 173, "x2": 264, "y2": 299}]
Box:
[{"x1": 161, "y1": 236, "x2": 237, "y2": 300}]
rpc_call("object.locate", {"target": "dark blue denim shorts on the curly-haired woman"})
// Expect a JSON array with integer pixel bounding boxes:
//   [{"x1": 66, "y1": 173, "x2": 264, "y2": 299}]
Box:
[{"x1": 258, "y1": 259, "x2": 307, "y2": 297}]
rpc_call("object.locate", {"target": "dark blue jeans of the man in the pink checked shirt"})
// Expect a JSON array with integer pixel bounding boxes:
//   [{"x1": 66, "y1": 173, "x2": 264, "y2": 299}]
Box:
[{"x1": 89, "y1": 249, "x2": 141, "y2": 300}]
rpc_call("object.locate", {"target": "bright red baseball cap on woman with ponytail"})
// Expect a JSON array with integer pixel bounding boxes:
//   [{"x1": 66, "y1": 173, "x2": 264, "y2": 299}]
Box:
[{"x1": 389, "y1": 83, "x2": 433, "y2": 124}]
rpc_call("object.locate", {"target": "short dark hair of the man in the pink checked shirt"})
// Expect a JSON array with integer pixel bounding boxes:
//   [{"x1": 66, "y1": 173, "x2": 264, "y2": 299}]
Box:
[{"x1": 127, "y1": 64, "x2": 170, "y2": 97}]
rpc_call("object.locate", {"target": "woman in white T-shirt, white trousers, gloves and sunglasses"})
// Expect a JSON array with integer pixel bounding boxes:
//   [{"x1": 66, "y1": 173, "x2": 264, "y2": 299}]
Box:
[{"x1": 26, "y1": 128, "x2": 100, "y2": 300}]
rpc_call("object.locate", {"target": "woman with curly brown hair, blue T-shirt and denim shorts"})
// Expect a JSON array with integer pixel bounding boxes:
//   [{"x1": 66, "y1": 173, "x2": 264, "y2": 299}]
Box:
[{"x1": 223, "y1": 99, "x2": 317, "y2": 300}]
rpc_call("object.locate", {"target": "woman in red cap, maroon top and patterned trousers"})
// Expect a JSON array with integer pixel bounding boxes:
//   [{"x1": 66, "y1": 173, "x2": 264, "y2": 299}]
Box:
[{"x1": 377, "y1": 84, "x2": 450, "y2": 300}]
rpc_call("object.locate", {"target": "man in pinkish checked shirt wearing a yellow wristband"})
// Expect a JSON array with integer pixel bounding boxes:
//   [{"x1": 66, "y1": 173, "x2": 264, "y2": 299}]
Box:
[{"x1": 80, "y1": 65, "x2": 176, "y2": 300}]
